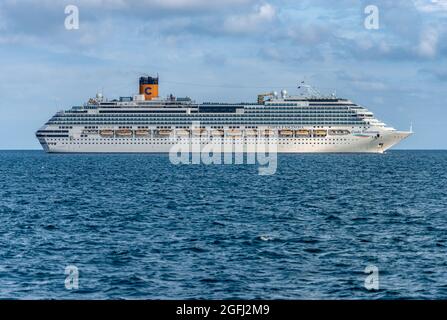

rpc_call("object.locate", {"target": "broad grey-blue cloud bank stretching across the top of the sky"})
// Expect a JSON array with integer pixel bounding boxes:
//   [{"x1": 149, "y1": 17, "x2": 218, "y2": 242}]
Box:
[{"x1": 0, "y1": 0, "x2": 447, "y2": 64}]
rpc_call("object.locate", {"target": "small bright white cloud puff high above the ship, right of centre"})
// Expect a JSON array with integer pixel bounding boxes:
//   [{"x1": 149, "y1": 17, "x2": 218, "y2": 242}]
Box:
[{"x1": 224, "y1": 3, "x2": 277, "y2": 33}]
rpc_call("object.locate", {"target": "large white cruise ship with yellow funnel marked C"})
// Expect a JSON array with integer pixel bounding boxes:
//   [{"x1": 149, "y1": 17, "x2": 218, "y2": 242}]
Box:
[{"x1": 36, "y1": 75, "x2": 412, "y2": 153}]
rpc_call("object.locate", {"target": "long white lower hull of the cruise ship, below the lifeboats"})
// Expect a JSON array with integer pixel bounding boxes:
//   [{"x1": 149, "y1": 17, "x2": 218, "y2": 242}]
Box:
[{"x1": 39, "y1": 131, "x2": 411, "y2": 153}]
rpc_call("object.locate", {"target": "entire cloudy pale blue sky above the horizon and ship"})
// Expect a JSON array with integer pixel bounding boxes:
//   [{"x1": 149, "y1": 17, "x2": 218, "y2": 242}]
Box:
[{"x1": 0, "y1": 0, "x2": 447, "y2": 149}]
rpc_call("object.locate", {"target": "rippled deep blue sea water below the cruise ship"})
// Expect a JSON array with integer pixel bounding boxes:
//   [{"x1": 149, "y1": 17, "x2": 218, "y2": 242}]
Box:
[{"x1": 0, "y1": 151, "x2": 447, "y2": 299}]
